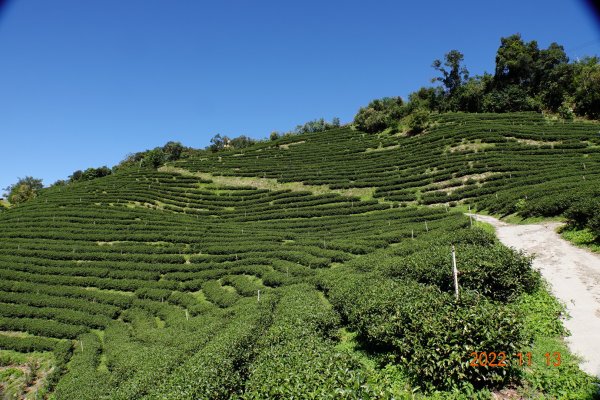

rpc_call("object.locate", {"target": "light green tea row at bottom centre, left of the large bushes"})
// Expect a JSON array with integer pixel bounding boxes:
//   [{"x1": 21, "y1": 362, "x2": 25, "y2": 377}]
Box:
[{"x1": 242, "y1": 284, "x2": 371, "y2": 399}]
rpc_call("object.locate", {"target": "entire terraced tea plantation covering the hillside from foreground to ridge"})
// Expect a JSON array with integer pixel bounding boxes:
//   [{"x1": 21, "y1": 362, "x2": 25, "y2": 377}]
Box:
[{"x1": 0, "y1": 113, "x2": 600, "y2": 400}]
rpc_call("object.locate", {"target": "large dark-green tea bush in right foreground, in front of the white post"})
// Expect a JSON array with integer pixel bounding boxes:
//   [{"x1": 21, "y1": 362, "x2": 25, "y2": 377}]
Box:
[{"x1": 325, "y1": 271, "x2": 526, "y2": 389}]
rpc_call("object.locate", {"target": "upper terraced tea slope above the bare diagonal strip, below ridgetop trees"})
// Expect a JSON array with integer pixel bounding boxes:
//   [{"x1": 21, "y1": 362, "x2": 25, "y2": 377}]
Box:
[{"x1": 173, "y1": 112, "x2": 600, "y2": 235}]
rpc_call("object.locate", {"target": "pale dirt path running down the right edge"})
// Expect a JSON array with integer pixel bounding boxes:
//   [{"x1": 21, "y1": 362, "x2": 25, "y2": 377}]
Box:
[{"x1": 475, "y1": 215, "x2": 600, "y2": 377}]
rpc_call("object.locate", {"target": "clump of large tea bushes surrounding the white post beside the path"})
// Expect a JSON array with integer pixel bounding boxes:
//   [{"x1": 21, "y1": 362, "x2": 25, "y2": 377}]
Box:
[{"x1": 322, "y1": 225, "x2": 539, "y2": 388}]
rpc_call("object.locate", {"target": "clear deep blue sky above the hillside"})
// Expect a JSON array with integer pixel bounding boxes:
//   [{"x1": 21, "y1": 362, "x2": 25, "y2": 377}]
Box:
[{"x1": 0, "y1": 0, "x2": 600, "y2": 188}]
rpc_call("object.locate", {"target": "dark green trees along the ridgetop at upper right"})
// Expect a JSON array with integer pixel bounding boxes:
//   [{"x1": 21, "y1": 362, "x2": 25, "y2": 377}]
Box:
[{"x1": 354, "y1": 34, "x2": 600, "y2": 133}]
